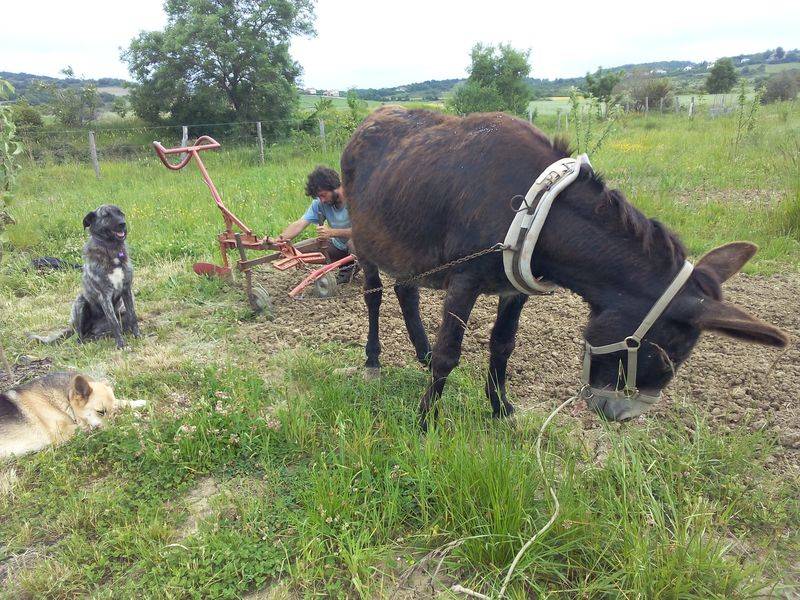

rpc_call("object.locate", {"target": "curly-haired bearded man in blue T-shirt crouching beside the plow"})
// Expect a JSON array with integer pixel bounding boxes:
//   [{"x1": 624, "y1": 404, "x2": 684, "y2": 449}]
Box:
[{"x1": 278, "y1": 166, "x2": 354, "y2": 283}]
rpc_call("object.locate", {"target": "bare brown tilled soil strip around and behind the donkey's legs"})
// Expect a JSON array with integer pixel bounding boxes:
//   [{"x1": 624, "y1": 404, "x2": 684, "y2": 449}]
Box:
[{"x1": 247, "y1": 270, "x2": 800, "y2": 469}]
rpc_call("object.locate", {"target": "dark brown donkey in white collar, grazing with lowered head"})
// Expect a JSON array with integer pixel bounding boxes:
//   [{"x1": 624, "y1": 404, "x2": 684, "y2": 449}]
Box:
[{"x1": 341, "y1": 107, "x2": 787, "y2": 428}]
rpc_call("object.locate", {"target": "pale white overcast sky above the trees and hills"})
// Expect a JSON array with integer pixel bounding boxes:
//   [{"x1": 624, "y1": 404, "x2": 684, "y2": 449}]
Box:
[{"x1": 0, "y1": 0, "x2": 800, "y2": 89}]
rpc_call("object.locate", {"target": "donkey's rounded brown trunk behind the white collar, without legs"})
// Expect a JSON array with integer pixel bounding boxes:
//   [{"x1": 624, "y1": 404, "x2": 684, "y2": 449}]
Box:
[{"x1": 341, "y1": 107, "x2": 564, "y2": 287}]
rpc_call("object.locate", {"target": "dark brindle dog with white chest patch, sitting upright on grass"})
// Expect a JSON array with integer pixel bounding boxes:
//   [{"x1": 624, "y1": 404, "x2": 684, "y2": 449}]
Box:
[{"x1": 30, "y1": 204, "x2": 139, "y2": 348}]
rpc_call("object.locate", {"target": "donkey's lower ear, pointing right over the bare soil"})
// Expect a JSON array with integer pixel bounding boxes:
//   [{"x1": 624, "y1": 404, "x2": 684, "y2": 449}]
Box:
[{"x1": 690, "y1": 300, "x2": 789, "y2": 348}]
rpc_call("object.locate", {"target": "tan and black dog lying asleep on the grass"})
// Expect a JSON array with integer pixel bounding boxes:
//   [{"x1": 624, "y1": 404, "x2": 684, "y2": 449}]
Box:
[{"x1": 0, "y1": 372, "x2": 145, "y2": 458}]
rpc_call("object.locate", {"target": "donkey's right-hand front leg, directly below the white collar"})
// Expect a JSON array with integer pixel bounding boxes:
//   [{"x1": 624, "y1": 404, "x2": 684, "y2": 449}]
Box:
[{"x1": 486, "y1": 294, "x2": 528, "y2": 417}]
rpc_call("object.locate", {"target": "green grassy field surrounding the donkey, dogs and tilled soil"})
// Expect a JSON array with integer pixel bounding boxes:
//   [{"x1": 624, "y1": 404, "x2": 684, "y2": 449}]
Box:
[{"x1": 0, "y1": 102, "x2": 800, "y2": 599}]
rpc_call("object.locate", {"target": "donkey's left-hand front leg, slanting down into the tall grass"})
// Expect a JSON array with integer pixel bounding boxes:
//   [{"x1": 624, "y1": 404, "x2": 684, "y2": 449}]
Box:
[{"x1": 419, "y1": 275, "x2": 478, "y2": 431}]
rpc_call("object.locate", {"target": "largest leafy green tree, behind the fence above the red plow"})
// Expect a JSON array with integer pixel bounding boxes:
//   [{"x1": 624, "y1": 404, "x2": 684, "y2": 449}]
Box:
[{"x1": 122, "y1": 0, "x2": 314, "y2": 131}]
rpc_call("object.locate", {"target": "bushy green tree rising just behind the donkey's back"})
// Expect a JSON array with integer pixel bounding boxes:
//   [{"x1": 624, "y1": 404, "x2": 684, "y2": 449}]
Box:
[{"x1": 450, "y1": 44, "x2": 533, "y2": 115}]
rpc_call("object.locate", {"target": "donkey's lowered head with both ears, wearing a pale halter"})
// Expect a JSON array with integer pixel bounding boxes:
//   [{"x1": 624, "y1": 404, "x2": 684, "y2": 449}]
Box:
[{"x1": 585, "y1": 242, "x2": 788, "y2": 420}]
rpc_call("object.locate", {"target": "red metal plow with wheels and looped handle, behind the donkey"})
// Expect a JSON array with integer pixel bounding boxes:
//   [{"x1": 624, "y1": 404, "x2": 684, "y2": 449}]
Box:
[{"x1": 153, "y1": 135, "x2": 355, "y2": 313}]
